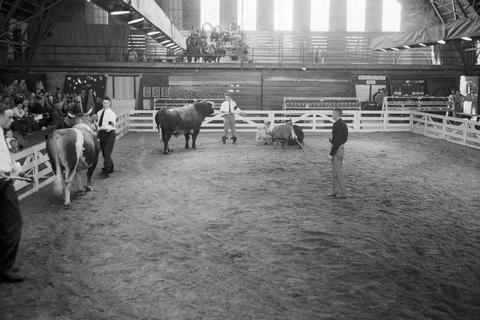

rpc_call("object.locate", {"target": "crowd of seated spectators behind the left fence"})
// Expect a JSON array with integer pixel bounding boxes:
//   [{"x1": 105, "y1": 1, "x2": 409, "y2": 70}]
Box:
[{"x1": 0, "y1": 79, "x2": 102, "y2": 152}]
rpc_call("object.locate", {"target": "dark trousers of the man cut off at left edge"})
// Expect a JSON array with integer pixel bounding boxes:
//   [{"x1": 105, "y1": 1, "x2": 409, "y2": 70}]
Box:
[{"x1": 0, "y1": 180, "x2": 23, "y2": 272}]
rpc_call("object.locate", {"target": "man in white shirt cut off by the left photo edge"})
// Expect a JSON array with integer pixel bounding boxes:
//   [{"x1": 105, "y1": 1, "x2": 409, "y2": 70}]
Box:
[{"x1": 0, "y1": 104, "x2": 26, "y2": 282}]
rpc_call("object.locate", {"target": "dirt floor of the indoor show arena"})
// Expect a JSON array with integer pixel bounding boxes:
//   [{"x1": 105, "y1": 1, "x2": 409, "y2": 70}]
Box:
[{"x1": 0, "y1": 133, "x2": 480, "y2": 320}]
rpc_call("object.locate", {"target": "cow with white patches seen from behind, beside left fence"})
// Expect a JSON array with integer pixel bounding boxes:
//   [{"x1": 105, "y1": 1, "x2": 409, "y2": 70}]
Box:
[{"x1": 46, "y1": 115, "x2": 100, "y2": 209}]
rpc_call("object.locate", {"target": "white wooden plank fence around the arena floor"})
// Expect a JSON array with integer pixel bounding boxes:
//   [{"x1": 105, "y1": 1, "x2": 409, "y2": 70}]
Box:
[{"x1": 13, "y1": 110, "x2": 480, "y2": 199}]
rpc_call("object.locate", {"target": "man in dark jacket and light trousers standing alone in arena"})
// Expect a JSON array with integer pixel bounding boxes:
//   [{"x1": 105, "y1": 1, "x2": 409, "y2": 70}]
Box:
[{"x1": 328, "y1": 108, "x2": 348, "y2": 199}]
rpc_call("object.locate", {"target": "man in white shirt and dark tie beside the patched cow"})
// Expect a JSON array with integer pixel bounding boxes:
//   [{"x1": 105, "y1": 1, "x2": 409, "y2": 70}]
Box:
[{"x1": 97, "y1": 97, "x2": 117, "y2": 178}]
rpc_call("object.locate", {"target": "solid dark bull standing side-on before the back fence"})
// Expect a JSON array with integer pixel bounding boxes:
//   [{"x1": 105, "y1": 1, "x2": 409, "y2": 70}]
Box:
[{"x1": 155, "y1": 101, "x2": 214, "y2": 154}]
